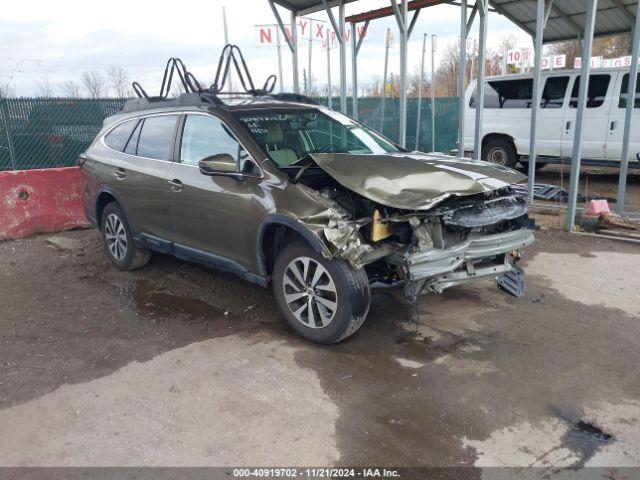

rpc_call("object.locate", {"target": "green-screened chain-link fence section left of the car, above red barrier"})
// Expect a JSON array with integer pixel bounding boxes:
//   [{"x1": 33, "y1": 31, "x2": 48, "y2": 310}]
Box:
[{"x1": 0, "y1": 98, "x2": 125, "y2": 170}]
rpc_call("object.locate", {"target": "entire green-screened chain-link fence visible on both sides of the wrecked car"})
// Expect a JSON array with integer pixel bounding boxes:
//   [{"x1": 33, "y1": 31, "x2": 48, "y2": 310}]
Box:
[{"x1": 0, "y1": 97, "x2": 458, "y2": 170}]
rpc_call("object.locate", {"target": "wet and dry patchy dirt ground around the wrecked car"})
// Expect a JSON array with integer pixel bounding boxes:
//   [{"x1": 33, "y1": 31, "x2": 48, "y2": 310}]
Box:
[{"x1": 0, "y1": 230, "x2": 640, "y2": 470}]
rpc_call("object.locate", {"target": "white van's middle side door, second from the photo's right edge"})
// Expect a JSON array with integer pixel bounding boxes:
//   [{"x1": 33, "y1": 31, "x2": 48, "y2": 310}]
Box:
[{"x1": 562, "y1": 73, "x2": 615, "y2": 159}]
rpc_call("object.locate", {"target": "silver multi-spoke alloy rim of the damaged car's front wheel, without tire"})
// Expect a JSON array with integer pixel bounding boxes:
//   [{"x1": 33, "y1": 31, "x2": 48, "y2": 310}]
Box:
[{"x1": 282, "y1": 257, "x2": 338, "y2": 328}]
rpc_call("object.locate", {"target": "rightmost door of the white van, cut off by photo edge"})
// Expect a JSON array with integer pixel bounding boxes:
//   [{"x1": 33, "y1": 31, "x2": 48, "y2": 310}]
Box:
[{"x1": 607, "y1": 72, "x2": 640, "y2": 161}]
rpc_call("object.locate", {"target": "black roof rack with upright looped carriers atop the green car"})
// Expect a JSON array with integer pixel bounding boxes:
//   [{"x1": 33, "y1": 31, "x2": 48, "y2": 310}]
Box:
[{"x1": 121, "y1": 44, "x2": 318, "y2": 112}]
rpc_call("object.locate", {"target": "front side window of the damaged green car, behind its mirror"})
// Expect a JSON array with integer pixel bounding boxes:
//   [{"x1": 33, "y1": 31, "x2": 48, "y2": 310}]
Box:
[{"x1": 180, "y1": 115, "x2": 242, "y2": 165}]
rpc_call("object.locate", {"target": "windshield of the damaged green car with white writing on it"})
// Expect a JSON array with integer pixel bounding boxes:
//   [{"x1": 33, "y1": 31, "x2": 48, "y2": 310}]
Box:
[{"x1": 232, "y1": 109, "x2": 399, "y2": 166}]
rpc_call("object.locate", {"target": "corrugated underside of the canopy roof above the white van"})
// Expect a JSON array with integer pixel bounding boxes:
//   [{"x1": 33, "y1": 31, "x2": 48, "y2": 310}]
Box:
[{"x1": 492, "y1": 0, "x2": 638, "y2": 43}]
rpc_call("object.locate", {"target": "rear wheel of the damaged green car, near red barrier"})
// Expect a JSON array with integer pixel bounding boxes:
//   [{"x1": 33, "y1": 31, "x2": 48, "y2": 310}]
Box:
[{"x1": 100, "y1": 202, "x2": 151, "y2": 270}]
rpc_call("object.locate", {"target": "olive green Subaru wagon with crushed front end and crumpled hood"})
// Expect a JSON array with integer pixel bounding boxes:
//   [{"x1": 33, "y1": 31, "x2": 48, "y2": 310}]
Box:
[{"x1": 80, "y1": 53, "x2": 534, "y2": 343}]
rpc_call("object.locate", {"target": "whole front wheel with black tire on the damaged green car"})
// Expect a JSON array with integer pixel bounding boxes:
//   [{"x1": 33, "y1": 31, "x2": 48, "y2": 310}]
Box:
[{"x1": 273, "y1": 242, "x2": 371, "y2": 344}]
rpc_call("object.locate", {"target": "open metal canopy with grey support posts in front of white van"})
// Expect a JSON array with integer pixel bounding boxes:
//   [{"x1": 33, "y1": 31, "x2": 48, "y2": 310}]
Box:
[{"x1": 267, "y1": 0, "x2": 640, "y2": 231}]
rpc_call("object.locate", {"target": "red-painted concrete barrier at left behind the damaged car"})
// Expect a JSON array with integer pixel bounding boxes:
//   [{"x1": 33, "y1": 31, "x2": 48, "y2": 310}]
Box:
[{"x1": 0, "y1": 167, "x2": 88, "y2": 240}]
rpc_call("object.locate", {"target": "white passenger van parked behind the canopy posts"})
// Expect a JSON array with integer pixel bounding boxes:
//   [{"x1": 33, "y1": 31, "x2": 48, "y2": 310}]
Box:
[{"x1": 464, "y1": 68, "x2": 640, "y2": 167}]
